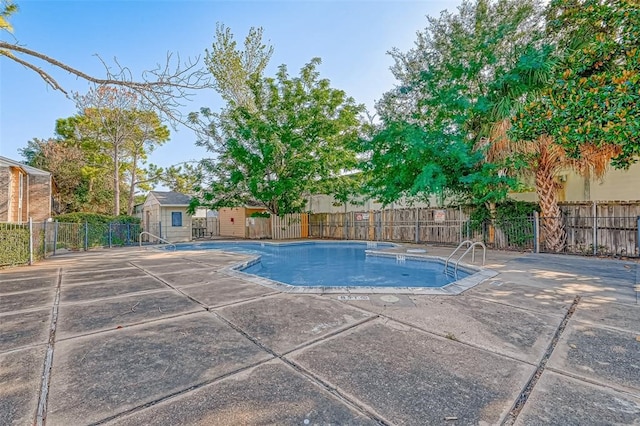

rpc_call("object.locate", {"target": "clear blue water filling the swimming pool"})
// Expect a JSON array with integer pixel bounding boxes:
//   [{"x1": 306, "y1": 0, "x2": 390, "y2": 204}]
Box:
[{"x1": 178, "y1": 242, "x2": 469, "y2": 287}]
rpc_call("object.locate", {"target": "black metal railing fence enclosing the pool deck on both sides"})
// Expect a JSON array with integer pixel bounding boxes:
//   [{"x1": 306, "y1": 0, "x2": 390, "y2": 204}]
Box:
[{"x1": 5, "y1": 211, "x2": 640, "y2": 267}]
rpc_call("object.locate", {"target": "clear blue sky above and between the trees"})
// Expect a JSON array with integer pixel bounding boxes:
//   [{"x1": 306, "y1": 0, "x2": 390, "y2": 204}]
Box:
[{"x1": 0, "y1": 0, "x2": 459, "y2": 171}]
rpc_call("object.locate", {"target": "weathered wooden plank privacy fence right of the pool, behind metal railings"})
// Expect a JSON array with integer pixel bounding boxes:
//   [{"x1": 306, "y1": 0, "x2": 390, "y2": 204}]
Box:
[{"x1": 309, "y1": 202, "x2": 640, "y2": 257}]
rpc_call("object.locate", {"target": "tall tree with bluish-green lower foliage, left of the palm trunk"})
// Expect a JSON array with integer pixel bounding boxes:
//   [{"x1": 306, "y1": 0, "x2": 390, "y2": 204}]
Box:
[{"x1": 363, "y1": 0, "x2": 542, "y2": 203}]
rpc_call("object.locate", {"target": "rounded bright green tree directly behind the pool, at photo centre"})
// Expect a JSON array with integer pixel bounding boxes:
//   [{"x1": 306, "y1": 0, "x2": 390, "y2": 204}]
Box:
[{"x1": 192, "y1": 58, "x2": 363, "y2": 215}]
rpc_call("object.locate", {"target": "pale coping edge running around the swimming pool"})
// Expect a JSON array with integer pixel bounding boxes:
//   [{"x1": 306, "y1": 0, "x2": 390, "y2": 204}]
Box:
[{"x1": 198, "y1": 240, "x2": 498, "y2": 296}]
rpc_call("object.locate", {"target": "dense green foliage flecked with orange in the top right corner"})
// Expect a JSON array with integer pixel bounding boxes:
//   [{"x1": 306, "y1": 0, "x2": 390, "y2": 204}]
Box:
[{"x1": 513, "y1": 0, "x2": 640, "y2": 161}]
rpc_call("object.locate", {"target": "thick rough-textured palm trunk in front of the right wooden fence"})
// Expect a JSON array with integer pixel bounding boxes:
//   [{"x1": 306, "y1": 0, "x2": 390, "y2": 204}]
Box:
[{"x1": 536, "y1": 146, "x2": 567, "y2": 252}]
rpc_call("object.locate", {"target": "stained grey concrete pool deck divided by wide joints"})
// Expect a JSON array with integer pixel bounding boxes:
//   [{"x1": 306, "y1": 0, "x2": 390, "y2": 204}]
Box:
[{"x1": 0, "y1": 246, "x2": 640, "y2": 425}]
